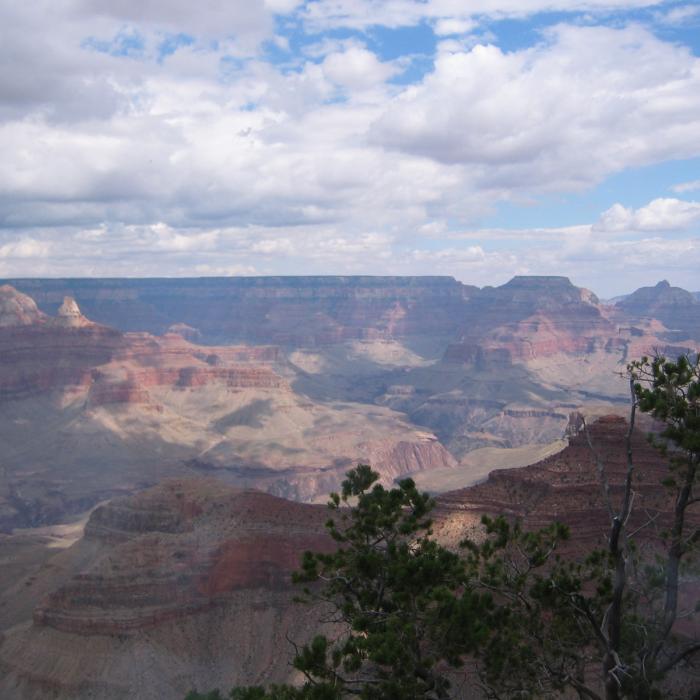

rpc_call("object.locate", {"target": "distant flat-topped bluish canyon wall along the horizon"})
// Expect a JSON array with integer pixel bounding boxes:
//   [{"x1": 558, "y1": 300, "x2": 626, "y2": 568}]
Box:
[{"x1": 0, "y1": 277, "x2": 476, "y2": 346}]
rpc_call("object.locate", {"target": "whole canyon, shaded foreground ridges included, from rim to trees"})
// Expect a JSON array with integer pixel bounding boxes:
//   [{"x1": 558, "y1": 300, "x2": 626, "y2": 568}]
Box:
[{"x1": 0, "y1": 277, "x2": 700, "y2": 700}]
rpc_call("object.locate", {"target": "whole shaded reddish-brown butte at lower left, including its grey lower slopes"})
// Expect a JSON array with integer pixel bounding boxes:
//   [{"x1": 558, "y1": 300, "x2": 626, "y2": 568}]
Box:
[{"x1": 0, "y1": 479, "x2": 334, "y2": 700}]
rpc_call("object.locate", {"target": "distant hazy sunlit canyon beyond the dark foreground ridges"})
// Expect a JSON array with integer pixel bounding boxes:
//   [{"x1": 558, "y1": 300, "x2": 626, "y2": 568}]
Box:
[{"x1": 0, "y1": 277, "x2": 700, "y2": 532}]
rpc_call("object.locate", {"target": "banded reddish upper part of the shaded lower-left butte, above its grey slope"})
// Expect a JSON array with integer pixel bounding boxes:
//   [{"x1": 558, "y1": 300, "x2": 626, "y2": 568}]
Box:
[{"x1": 34, "y1": 480, "x2": 331, "y2": 635}]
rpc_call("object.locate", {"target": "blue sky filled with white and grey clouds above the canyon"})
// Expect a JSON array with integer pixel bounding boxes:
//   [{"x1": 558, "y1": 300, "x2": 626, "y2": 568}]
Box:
[{"x1": 0, "y1": 0, "x2": 700, "y2": 298}]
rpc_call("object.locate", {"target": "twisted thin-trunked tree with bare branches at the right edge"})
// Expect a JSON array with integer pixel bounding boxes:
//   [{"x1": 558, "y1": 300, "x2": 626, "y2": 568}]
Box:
[{"x1": 583, "y1": 356, "x2": 700, "y2": 700}]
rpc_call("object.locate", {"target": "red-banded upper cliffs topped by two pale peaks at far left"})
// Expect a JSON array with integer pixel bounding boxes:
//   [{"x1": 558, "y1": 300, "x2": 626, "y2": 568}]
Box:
[{"x1": 0, "y1": 286, "x2": 284, "y2": 406}]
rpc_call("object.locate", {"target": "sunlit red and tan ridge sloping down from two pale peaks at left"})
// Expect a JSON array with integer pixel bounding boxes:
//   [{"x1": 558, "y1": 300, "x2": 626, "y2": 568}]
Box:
[{"x1": 0, "y1": 287, "x2": 455, "y2": 531}]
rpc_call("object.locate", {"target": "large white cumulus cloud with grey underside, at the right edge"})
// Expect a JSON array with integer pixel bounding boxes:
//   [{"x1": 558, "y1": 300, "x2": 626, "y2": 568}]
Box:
[{"x1": 372, "y1": 25, "x2": 700, "y2": 190}]
